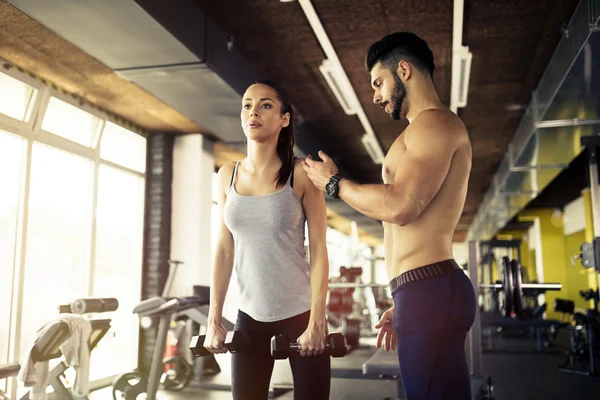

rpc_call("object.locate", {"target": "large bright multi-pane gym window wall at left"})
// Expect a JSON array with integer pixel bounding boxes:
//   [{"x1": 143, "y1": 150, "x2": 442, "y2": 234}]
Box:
[{"x1": 0, "y1": 68, "x2": 146, "y2": 398}]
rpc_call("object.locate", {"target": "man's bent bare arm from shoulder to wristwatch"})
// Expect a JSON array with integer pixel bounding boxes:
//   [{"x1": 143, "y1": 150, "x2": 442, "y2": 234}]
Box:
[{"x1": 339, "y1": 111, "x2": 460, "y2": 226}]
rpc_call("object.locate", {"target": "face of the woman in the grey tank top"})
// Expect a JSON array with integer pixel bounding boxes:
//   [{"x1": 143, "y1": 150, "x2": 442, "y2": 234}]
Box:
[{"x1": 241, "y1": 84, "x2": 290, "y2": 141}]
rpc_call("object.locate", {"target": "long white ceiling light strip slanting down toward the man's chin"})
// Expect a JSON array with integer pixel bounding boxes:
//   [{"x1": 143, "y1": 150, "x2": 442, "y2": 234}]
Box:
[{"x1": 298, "y1": 0, "x2": 385, "y2": 164}]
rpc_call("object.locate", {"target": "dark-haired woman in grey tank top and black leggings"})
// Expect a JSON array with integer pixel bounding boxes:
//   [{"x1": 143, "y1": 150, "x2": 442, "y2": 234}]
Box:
[{"x1": 204, "y1": 81, "x2": 331, "y2": 400}]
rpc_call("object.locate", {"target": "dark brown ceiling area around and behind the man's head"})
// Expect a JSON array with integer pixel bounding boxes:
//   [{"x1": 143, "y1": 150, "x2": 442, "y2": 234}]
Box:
[{"x1": 194, "y1": 0, "x2": 578, "y2": 241}]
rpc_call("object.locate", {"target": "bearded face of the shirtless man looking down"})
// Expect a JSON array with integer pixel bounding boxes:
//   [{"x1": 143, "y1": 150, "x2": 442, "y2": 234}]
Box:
[{"x1": 371, "y1": 63, "x2": 407, "y2": 120}]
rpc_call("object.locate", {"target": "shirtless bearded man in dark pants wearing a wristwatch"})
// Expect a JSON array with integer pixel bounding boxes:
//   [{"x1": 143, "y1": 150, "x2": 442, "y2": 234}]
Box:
[{"x1": 303, "y1": 32, "x2": 475, "y2": 400}]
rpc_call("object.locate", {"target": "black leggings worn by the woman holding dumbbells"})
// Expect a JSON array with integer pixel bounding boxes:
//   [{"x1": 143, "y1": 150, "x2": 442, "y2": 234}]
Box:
[{"x1": 231, "y1": 311, "x2": 331, "y2": 400}]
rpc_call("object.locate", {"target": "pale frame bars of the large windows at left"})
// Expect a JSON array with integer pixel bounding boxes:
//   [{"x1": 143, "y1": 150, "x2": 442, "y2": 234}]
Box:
[{"x1": 0, "y1": 59, "x2": 148, "y2": 396}]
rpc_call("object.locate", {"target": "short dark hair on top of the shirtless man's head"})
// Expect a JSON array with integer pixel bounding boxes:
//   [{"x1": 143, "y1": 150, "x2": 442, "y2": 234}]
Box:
[{"x1": 366, "y1": 32, "x2": 435, "y2": 79}]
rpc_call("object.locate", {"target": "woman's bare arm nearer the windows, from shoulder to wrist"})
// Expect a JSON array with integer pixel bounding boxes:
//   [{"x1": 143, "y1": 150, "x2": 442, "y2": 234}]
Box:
[{"x1": 208, "y1": 163, "x2": 234, "y2": 325}]
